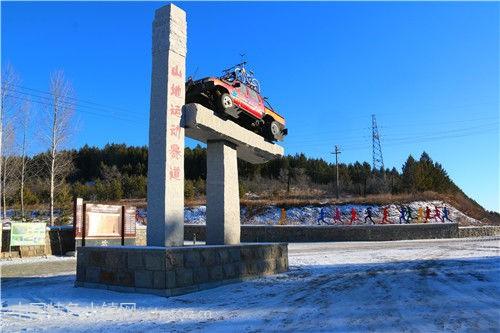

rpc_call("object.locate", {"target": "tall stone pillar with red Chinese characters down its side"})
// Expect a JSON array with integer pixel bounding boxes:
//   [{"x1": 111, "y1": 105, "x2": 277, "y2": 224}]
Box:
[{"x1": 147, "y1": 4, "x2": 187, "y2": 246}]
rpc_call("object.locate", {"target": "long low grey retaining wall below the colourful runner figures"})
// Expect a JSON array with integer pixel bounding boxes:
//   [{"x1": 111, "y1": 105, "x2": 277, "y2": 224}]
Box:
[{"x1": 180, "y1": 223, "x2": 459, "y2": 242}]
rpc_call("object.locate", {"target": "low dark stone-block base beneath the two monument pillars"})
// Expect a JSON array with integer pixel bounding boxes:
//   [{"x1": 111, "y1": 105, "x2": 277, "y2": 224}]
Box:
[{"x1": 75, "y1": 243, "x2": 288, "y2": 296}]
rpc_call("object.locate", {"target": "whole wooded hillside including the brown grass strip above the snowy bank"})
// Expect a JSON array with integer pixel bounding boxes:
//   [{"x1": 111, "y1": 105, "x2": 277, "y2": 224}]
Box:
[{"x1": 5, "y1": 144, "x2": 500, "y2": 224}]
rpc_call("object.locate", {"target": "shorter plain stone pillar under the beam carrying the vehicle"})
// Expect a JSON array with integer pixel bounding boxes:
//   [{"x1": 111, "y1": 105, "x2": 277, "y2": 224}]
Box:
[{"x1": 206, "y1": 140, "x2": 240, "y2": 245}]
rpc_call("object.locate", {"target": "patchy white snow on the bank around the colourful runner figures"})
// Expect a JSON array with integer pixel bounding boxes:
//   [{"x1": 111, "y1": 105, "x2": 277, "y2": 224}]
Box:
[{"x1": 184, "y1": 201, "x2": 481, "y2": 225}]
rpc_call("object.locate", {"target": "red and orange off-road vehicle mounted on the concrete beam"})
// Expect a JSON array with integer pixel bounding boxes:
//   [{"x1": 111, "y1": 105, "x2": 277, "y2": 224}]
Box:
[{"x1": 186, "y1": 67, "x2": 288, "y2": 141}]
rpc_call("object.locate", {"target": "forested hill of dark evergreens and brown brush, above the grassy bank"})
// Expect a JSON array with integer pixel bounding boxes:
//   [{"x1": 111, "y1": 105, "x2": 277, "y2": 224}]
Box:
[{"x1": 7, "y1": 144, "x2": 498, "y2": 222}]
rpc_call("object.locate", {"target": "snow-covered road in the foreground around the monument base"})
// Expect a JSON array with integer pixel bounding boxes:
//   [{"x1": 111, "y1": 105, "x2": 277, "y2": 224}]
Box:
[{"x1": 2, "y1": 239, "x2": 500, "y2": 332}]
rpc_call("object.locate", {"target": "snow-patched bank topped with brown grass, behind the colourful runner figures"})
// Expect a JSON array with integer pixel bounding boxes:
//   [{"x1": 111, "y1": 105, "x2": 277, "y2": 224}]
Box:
[{"x1": 121, "y1": 192, "x2": 500, "y2": 226}]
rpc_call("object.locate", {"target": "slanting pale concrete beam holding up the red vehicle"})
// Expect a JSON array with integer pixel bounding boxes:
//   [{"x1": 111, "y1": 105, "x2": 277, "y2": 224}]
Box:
[{"x1": 183, "y1": 103, "x2": 284, "y2": 164}]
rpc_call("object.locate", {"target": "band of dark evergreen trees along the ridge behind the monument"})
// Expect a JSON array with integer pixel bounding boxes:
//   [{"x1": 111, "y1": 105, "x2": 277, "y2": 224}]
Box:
[{"x1": 67, "y1": 144, "x2": 460, "y2": 196}]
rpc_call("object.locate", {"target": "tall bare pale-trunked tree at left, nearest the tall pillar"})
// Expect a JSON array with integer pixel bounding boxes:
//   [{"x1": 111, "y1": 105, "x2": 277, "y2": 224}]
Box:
[{"x1": 45, "y1": 71, "x2": 75, "y2": 225}]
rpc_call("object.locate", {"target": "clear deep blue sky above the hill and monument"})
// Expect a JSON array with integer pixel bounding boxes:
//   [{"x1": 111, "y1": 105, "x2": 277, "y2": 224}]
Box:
[{"x1": 1, "y1": 2, "x2": 500, "y2": 211}]
